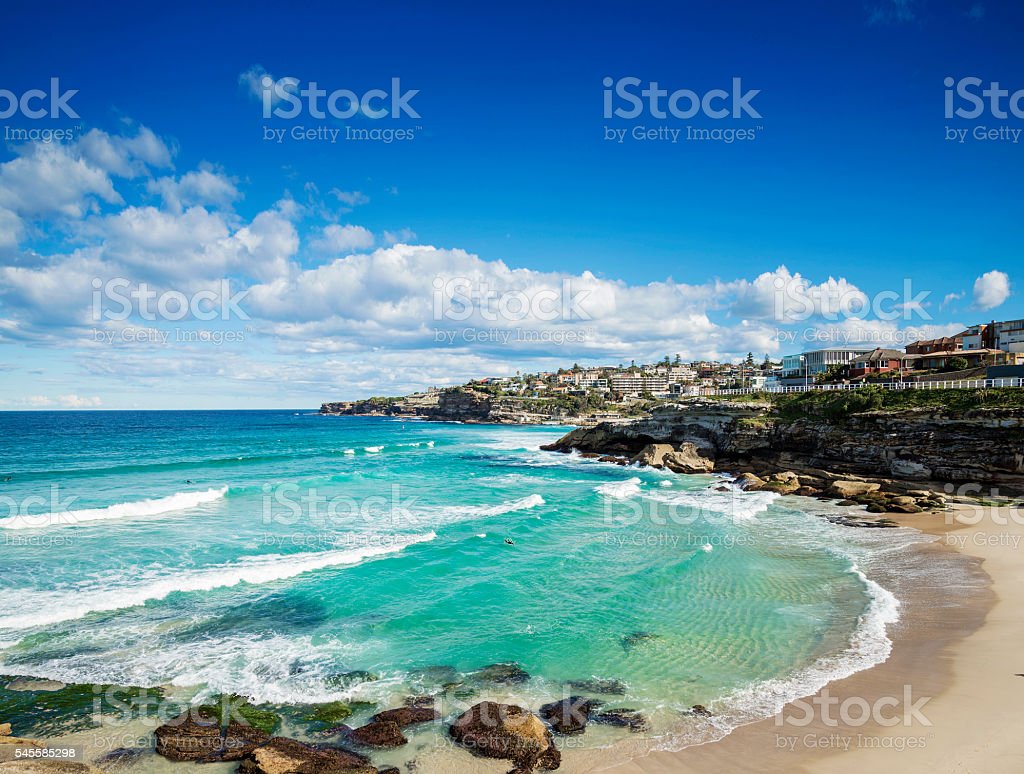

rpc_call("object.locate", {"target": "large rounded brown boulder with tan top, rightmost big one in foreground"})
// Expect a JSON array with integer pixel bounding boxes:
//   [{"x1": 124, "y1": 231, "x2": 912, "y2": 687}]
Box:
[{"x1": 449, "y1": 701, "x2": 561, "y2": 772}]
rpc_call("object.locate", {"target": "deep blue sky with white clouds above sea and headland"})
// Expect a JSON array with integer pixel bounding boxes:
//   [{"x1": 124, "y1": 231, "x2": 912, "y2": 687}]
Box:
[{"x1": 0, "y1": 0, "x2": 1024, "y2": 409}]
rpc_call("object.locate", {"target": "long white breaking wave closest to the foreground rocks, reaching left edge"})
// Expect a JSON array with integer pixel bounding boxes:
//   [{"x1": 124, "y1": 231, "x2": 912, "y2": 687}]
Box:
[{"x1": 0, "y1": 532, "x2": 437, "y2": 630}]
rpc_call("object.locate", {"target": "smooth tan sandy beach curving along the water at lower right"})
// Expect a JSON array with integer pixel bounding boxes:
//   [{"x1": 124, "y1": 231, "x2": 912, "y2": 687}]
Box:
[{"x1": 606, "y1": 506, "x2": 1024, "y2": 774}]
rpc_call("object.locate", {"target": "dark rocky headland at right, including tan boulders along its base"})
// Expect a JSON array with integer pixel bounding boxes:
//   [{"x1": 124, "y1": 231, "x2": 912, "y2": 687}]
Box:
[{"x1": 543, "y1": 391, "x2": 1024, "y2": 501}]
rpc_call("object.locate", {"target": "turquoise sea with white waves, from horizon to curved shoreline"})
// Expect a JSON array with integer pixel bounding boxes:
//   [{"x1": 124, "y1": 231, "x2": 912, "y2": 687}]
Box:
[{"x1": 0, "y1": 411, "x2": 918, "y2": 747}]
